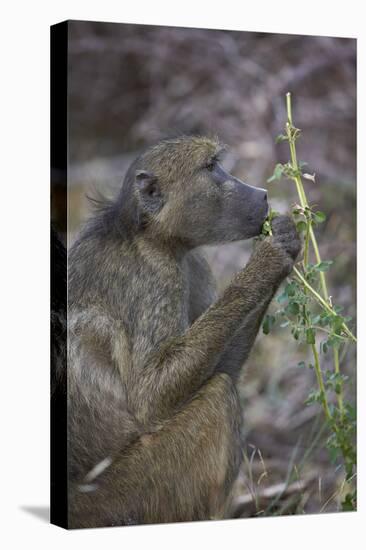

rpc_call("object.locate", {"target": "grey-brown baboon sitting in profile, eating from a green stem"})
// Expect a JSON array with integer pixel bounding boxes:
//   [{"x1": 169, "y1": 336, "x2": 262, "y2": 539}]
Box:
[{"x1": 68, "y1": 137, "x2": 300, "y2": 527}]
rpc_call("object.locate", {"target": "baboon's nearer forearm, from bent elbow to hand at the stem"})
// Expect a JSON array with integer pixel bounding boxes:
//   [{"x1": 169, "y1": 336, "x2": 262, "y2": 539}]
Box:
[{"x1": 129, "y1": 239, "x2": 293, "y2": 422}]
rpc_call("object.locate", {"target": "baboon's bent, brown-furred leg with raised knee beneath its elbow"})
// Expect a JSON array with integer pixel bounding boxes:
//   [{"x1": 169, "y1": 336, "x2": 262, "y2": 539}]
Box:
[{"x1": 70, "y1": 374, "x2": 241, "y2": 527}]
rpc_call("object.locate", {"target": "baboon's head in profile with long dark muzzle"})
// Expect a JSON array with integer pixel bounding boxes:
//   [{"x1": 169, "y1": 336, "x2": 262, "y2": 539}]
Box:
[{"x1": 121, "y1": 137, "x2": 268, "y2": 248}]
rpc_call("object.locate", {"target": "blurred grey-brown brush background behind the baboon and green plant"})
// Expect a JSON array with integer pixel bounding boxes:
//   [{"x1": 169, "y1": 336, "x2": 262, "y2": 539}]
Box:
[{"x1": 59, "y1": 21, "x2": 356, "y2": 517}]
